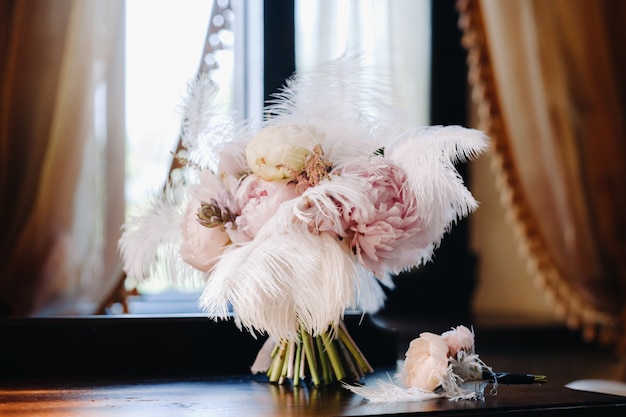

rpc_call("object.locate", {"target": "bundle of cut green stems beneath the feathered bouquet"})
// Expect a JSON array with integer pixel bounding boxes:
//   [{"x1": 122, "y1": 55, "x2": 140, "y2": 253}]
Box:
[{"x1": 266, "y1": 323, "x2": 373, "y2": 387}]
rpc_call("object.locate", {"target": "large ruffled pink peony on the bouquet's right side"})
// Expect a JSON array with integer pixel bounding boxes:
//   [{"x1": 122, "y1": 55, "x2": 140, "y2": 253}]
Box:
[{"x1": 339, "y1": 157, "x2": 430, "y2": 278}]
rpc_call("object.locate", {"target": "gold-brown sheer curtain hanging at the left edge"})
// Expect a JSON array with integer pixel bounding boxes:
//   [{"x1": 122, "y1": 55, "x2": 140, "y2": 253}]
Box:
[{"x1": 0, "y1": 0, "x2": 124, "y2": 316}]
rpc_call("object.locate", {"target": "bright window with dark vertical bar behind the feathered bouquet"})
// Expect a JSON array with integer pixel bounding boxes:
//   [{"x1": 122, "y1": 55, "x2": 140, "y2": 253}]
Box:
[{"x1": 116, "y1": 0, "x2": 430, "y2": 312}]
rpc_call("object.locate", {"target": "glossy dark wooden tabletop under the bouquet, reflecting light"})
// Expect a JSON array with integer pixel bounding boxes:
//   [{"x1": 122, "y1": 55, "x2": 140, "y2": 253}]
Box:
[{"x1": 0, "y1": 368, "x2": 626, "y2": 417}]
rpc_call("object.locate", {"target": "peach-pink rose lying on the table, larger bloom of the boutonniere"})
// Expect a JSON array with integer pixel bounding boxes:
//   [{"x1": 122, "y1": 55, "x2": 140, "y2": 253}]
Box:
[{"x1": 401, "y1": 332, "x2": 448, "y2": 391}]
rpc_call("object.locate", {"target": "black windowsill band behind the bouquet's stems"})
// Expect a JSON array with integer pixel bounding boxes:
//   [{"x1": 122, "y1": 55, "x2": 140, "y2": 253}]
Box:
[{"x1": 0, "y1": 312, "x2": 397, "y2": 379}]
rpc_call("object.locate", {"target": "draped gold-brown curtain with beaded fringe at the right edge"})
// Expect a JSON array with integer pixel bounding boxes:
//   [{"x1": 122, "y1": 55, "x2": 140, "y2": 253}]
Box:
[{"x1": 458, "y1": 0, "x2": 626, "y2": 354}]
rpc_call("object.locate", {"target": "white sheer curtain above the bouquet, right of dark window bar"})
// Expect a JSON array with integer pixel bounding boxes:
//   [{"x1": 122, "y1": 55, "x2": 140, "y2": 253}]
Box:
[{"x1": 295, "y1": 0, "x2": 430, "y2": 125}]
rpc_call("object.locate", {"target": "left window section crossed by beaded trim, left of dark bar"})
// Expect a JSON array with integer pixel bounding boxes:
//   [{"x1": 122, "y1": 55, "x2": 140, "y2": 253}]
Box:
[{"x1": 120, "y1": 0, "x2": 262, "y2": 311}]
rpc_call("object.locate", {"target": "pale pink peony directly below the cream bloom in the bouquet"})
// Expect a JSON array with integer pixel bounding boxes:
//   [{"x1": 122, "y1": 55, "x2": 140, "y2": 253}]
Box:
[{"x1": 235, "y1": 174, "x2": 297, "y2": 239}]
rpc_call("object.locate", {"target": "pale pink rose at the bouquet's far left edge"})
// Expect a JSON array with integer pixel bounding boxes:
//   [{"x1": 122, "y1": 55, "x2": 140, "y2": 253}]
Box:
[{"x1": 180, "y1": 199, "x2": 230, "y2": 272}]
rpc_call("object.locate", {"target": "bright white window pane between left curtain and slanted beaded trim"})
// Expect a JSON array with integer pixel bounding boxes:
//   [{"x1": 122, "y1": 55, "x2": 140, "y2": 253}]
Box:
[{"x1": 125, "y1": 0, "x2": 217, "y2": 216}]
